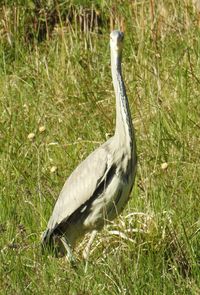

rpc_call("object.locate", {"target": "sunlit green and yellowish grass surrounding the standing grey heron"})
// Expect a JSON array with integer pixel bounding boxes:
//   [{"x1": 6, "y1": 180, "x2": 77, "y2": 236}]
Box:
[{"x1": 0, "y1": 0, "x2": 200, "y2": 294}]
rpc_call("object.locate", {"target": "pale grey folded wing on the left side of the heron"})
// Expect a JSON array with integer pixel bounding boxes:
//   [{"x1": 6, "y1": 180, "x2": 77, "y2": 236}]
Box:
[{"x1": 47, "y1": 144, "x2": 112, "y2": 234}]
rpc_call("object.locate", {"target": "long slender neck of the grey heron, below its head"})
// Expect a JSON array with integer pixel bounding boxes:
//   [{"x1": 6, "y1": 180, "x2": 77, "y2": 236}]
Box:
[{"x1": 111, "y1": 48, "x2": 135, "y2": 150}]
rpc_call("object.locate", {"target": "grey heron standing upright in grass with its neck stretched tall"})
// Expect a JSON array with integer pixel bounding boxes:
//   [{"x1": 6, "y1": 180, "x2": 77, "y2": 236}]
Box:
[{"x1": 41, "y1": 30, "x2": 137, "y2": 261}]
